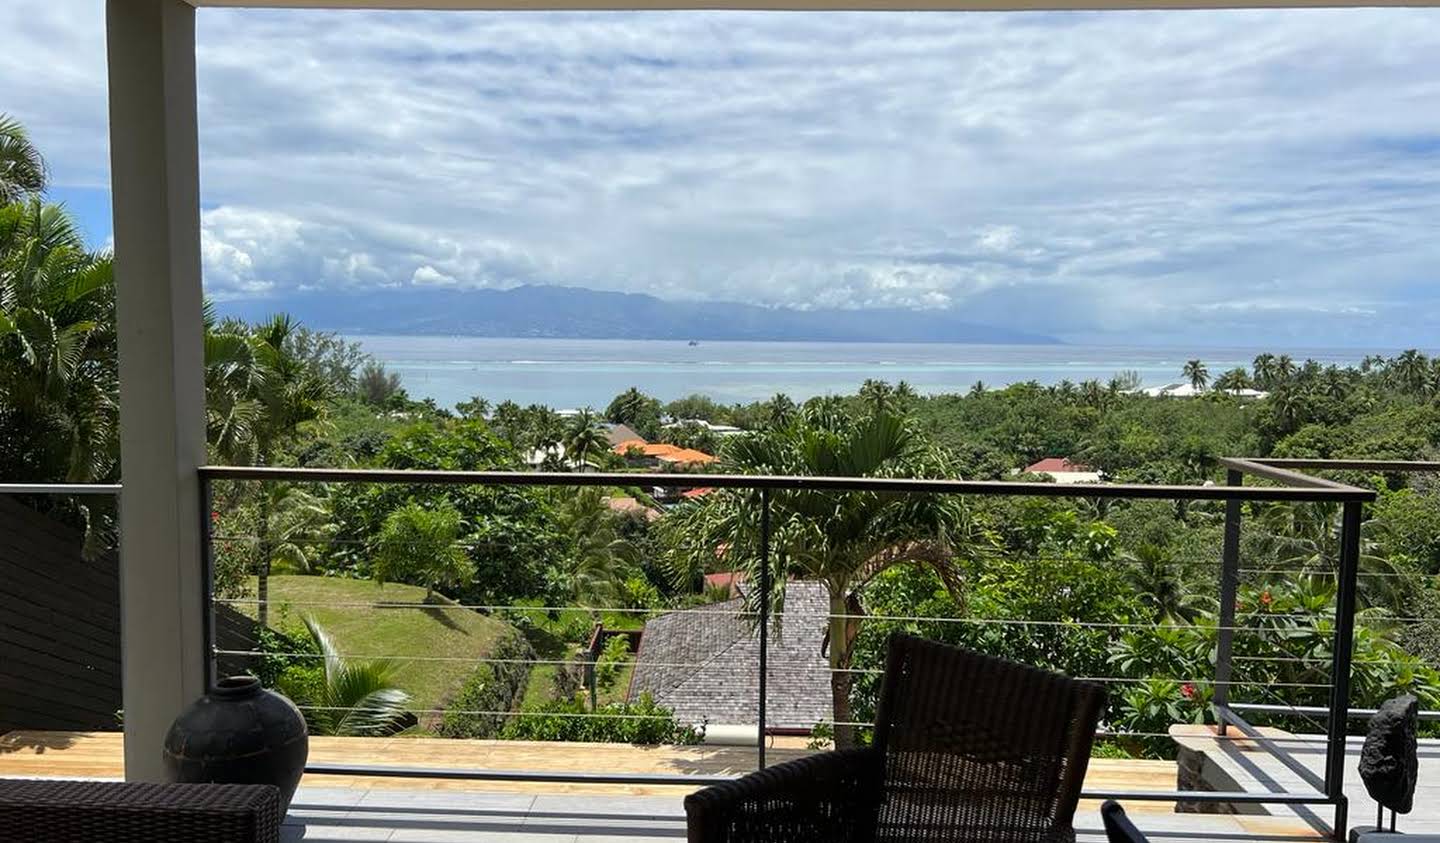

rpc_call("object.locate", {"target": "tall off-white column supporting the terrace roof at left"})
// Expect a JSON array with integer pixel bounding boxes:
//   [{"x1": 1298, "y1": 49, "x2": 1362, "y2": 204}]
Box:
[{"x1": 107, "y1": 0, "x2": 204, "y2": 781}]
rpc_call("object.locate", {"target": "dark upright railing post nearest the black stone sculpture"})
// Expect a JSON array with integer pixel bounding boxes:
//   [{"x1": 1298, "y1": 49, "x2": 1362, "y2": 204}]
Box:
[{"x1": 1325, "y1": 500, "x2": 1365, "y2": 840}]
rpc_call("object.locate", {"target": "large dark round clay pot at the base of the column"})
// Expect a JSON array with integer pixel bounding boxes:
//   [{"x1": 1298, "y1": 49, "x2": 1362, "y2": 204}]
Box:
[{"x1": 164, "y1": 676, "x2": 310, "y2": 811}]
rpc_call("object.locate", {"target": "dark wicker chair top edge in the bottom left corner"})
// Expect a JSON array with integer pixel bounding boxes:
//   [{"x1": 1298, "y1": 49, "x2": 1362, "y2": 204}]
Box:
[{"x1": 0, "y1": 780, "x2": 281, "y2": 843}]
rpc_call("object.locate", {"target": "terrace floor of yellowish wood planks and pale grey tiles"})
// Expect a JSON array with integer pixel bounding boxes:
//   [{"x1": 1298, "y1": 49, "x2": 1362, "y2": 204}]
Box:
[{"x1": 0, "y1": 732, "x2": 1316, "y2": 843}]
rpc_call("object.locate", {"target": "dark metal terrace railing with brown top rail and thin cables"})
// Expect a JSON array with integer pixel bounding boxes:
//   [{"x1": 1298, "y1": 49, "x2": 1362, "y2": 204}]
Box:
[{"x1": 200, "y1": 460, "x2": 1376, "y2": 834}]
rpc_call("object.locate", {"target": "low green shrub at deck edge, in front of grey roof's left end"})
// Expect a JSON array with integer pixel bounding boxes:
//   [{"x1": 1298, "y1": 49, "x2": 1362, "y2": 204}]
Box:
[{"x1": 501, "y1": 695, "x2": 704, "y2": 745}]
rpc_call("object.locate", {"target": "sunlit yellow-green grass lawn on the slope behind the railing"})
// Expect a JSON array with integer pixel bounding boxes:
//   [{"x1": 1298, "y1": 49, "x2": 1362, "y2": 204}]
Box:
[{"x1": 248, "y1": 575, "x2": 514, "y2": 708}]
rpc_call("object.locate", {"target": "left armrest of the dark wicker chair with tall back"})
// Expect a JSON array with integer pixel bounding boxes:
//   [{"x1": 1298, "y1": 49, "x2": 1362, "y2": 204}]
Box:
[{"x1": 685, "y1": 748, "x2": 881, "y2": 843}]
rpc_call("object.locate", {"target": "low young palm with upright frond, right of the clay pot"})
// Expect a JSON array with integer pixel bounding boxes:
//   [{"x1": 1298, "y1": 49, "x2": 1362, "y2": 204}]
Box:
[{"x1": 287, "y1": 617, "x2": 410, "y2": 736}]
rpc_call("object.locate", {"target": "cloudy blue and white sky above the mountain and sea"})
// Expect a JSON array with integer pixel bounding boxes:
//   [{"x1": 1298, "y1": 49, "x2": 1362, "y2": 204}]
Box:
[{"x1": 0, "y1": 0, "x2": 1440, "y2": 349}]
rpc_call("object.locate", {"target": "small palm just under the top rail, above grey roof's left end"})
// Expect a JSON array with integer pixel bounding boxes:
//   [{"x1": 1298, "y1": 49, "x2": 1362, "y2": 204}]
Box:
[{"x1": 559, "y1": 486, "x2": 635, "y2": 605}]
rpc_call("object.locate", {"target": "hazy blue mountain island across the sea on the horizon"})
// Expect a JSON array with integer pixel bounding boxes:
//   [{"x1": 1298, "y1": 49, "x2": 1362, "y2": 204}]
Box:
[{"x1": 217, "y1": 285, "x2": 1057, "y2": 344}]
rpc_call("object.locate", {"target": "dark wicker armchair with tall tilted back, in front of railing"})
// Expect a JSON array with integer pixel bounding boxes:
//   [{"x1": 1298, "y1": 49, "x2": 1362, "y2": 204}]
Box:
[{"x1": 685, "y1": 635, "x2": 1104, "y2": 843}]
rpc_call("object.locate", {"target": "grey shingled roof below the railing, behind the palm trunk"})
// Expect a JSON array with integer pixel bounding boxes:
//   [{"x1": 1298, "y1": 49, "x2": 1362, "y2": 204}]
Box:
[{"x1": 629, "y1": 582, "x2": 832, "y2": 729}]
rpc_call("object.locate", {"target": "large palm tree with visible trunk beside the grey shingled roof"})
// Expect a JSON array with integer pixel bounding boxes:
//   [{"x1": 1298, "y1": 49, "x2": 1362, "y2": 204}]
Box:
[{"x1": 664, "y1": 402, "x2": 966, "y2": 746}]
